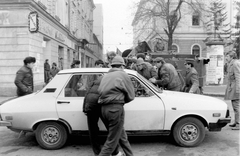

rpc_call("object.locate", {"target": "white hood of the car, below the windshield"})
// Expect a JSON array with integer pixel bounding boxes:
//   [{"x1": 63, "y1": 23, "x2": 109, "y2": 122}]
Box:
[{"x1": 160, "y1": 91, "x2": 227, "y2": 110}]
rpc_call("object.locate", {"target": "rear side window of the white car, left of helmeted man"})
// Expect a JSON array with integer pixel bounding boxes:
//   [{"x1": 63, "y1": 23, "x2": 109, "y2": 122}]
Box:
[{"x1": 64, "y1": 74, "x2": 102, "y2": 97}]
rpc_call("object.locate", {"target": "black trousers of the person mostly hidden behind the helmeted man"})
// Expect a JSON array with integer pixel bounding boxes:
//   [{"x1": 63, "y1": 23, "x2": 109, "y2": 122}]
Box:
[{"x1": 87, "y1": 107, "x2": 119, "y2": 155}]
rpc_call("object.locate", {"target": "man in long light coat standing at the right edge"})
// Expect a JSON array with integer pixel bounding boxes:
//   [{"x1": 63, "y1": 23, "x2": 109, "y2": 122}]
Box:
[{"x1": 225, "y1": 51, "x2": 240, "y2": 130}]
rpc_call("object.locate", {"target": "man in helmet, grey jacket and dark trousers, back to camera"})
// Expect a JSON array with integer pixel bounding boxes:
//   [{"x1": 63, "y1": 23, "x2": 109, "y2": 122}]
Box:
[{"x1": 98, "y1": 56, "x2": 135, "y2": 156}]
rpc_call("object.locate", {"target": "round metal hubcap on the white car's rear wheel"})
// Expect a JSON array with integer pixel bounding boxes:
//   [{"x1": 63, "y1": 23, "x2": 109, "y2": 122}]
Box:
[{"x1": 42, "y1": 127, "x2": 60, "y2": 145}]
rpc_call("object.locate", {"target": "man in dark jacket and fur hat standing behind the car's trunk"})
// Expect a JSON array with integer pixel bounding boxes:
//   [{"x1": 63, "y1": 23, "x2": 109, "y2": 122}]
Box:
[{"x1": 14, "y1": 56, "x2": 36, "y2": 96}]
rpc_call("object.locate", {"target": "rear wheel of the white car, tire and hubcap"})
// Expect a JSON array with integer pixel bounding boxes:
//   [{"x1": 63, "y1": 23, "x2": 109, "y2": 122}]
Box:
[{"x1": 35, "y1": 122, "x2": 68, "y2": 150}]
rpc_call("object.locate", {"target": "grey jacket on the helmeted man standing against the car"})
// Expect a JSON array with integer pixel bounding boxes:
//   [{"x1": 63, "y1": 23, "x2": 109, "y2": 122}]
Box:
[{"x1": 98, "y1": 68, "x2": 135, "y2": 104}]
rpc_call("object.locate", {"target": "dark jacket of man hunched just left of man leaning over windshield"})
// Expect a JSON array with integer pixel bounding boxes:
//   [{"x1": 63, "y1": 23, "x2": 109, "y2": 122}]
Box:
[{"x1": 137, "y1": 62, "x2": 157, "y2": 80}]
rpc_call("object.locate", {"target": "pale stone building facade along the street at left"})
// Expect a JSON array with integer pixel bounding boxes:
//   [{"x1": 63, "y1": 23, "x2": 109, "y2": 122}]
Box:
[{"x1": 0, "y1": 0, "x2": 102, "y2": 96}]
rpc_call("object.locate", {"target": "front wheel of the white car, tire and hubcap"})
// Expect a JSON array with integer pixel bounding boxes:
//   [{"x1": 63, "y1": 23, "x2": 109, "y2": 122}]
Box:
[{"x1": 173, "y1": 117, "x2": 205, "y2": 147}]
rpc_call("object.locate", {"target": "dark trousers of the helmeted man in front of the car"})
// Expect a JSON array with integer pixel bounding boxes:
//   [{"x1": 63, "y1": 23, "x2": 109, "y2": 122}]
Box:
[{"x1": 99, "y1": 104, "x2": 133, "y2": 156}]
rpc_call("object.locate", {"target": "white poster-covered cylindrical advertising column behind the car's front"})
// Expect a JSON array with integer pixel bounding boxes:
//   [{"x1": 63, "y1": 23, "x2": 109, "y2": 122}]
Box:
[{"x1": 206, "y1": 45, "x2": 224, "y2": 84}]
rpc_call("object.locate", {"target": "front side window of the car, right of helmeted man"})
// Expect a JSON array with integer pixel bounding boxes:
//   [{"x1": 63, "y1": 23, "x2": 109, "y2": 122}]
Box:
[{"x1": 130, "y1": 76, "x2": 154, "y2": 97}]
